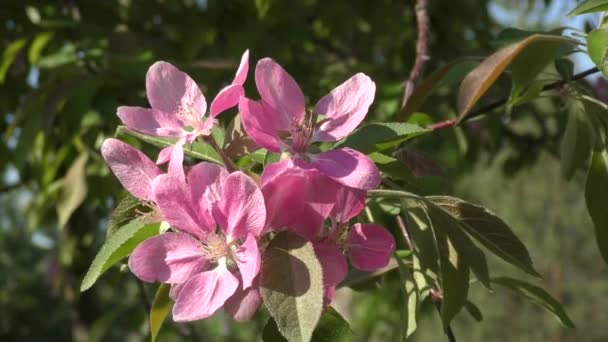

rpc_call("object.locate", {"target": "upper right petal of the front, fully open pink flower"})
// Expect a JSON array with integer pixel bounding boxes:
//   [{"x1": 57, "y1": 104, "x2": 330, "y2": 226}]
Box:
[{"x1": 214, "y1": 171, "x2": 266, "y2": 240}]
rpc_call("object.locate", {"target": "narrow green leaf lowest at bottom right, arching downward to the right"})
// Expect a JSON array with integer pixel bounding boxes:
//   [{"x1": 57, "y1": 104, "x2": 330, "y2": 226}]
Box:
[{"x1": 492, "y1": 277, "x2": 574, "y2": 328}]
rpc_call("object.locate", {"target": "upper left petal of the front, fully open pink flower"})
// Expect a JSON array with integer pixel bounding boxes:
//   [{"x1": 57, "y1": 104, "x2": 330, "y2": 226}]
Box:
[{"x1": 152, "y1": 175, "x2": 215, "y2": 239}]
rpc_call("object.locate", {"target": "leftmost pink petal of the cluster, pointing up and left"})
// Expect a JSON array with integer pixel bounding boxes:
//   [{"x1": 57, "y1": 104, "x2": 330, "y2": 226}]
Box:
[{"x1": 101, "y1": 138, "x2": 162, "y2": 201}]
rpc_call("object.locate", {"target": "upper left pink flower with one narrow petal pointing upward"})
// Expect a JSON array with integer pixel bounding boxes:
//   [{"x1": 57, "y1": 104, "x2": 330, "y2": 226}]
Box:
[{"x1": 117, "y1": 50, "x2": 249, "y2": 164}]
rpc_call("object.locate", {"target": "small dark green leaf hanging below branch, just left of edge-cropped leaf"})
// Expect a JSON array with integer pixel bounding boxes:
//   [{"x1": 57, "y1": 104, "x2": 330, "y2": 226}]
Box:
[{"x1": 560, "y1": 101, "x2": 592, "y2": 179}]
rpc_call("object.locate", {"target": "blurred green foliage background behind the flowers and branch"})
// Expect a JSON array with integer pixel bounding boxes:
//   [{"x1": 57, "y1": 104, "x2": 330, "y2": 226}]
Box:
[{"x1": 0, "y1": 0, "x2": 608, "y2": 341}]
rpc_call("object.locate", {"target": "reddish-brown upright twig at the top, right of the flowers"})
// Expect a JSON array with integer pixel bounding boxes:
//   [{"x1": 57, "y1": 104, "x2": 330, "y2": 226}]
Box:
[{"x1": 401, "y1": 0, "x2": 429, "y2": 108}]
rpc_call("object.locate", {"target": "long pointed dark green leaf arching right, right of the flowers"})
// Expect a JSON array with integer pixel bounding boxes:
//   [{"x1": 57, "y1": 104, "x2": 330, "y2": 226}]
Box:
[{"x1": 427, "y1": 196, "x2": 540, "y2": 277}]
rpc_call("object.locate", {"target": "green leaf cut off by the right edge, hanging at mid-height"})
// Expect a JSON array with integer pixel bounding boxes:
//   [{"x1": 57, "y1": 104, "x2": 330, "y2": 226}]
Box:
[{"x1": 585, "y1": 150, "x2": 608, "y2": 263}]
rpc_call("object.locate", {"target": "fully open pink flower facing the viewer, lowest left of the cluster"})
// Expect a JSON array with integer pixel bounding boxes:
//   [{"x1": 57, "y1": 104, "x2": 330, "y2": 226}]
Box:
[{"x1": 129, "y1": 163, "x2": 266, "y2": 321}]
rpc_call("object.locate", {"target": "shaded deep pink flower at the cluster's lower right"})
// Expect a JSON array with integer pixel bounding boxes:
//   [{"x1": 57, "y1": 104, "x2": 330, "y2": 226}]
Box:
[{"x1": 262, "y1": 164, "x2": 395, "y2": 305}]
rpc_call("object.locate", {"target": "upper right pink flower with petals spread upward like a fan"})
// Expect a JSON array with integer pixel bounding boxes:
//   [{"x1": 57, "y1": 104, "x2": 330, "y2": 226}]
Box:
[{"x1": 239, "y1": 58, "x2": 380, "y2": 189}]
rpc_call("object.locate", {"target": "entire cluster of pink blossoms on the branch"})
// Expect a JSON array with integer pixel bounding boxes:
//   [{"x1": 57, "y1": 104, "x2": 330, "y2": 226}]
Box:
[{"x1": 102, "y1": 51, "x2": 395, "y2": 321}]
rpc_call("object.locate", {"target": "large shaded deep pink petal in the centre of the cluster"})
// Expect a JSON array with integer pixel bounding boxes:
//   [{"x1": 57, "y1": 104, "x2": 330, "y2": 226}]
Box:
[{"x1": 262, "y1": 167, "x2": 337, "y2": 239}]
